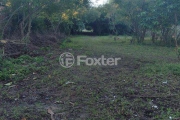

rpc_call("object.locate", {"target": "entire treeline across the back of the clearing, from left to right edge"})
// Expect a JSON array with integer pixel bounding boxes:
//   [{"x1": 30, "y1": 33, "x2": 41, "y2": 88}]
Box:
[{"x1": 0, "y1": 0, "x2": 180, "y2": 46}]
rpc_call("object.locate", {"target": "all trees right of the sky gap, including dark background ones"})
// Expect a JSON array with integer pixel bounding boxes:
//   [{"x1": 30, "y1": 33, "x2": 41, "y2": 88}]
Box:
[{"x1": 93, "y1": 0, "x2": 180, "y2": 46}]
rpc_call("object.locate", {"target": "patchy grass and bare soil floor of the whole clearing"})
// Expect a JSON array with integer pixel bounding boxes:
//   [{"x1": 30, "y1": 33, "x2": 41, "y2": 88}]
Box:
[{"x1": 0, "y1": 36, "x2": 180, "y2": 120}]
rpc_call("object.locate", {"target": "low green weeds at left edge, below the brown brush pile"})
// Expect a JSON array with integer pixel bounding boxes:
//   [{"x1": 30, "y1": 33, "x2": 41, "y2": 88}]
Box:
[{"x1": 0, "y1": 55, "x2": 44, "y2": 81}]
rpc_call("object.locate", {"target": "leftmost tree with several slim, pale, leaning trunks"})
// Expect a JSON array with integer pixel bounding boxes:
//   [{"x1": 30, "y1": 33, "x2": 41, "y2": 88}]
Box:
[{"x1": 3, "y1": 0, "x2": 48, "y2": 42}]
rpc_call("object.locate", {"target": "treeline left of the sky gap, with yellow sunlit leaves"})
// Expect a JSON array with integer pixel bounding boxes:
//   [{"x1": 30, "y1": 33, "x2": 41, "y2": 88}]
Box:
[{"x1": 0, "y1": 0, "x2": 90, "y2": 39}]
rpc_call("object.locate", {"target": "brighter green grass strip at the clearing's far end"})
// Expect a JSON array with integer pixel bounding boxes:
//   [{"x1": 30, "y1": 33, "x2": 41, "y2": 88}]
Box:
[{"x1": 67, "y1": 36, "x2": 177, "y2": 61}]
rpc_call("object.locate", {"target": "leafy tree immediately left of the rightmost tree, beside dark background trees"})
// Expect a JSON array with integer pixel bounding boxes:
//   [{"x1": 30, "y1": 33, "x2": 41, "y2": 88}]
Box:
[{"x1": 114, "y1": 0, "x2": 152, "y2": 43}]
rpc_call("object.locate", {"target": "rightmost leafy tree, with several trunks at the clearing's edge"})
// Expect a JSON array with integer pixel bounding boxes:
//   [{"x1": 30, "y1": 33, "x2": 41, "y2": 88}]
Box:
[{"x1": 146, "y1": 0, "x2": 180, "y2": 46}]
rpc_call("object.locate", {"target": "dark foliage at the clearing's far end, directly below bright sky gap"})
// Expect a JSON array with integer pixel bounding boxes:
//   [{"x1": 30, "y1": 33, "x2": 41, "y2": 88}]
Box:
[{"x1": 85, "y1": 4, "x2": 129, "y2": 35}]
